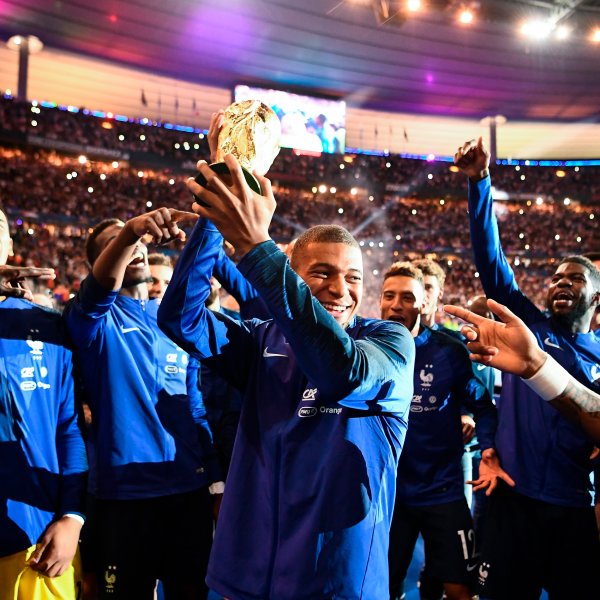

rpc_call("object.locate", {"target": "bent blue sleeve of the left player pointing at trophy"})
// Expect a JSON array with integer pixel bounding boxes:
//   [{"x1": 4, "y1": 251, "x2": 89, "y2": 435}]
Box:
[{"x1": 63, "y1": 273, "x2": 119, "y2": 348}]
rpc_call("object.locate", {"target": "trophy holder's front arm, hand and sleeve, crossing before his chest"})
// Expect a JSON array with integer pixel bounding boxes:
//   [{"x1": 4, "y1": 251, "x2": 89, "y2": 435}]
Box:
[{"x1": 178, "y1": 155, "x2": 414, "y2": 408}]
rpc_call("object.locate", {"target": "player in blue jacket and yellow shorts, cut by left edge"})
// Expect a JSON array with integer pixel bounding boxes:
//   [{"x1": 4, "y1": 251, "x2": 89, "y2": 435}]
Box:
[{"x1": 0, "y1": 211, "x2": 87, "y2": 600}]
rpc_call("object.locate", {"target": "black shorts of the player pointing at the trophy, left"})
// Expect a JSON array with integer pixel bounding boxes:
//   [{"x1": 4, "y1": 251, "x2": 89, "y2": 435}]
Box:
[{"x1": 94, "y1": 488, "x2": 213, "y2": 600}]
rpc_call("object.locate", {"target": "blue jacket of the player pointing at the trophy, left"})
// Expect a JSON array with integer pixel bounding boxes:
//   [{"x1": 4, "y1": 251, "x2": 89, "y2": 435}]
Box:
[{"x1": 64, "y1": 274, "x2": 210, "y2": 500}]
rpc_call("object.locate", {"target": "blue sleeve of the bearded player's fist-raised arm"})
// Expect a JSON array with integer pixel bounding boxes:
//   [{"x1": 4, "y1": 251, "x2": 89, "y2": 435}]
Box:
[{"x1": 469, "y1": 176, "x2": 542, "y2": 322}]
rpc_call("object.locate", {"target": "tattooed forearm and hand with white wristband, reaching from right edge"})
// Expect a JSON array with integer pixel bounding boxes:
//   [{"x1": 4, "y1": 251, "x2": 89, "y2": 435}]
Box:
[{"x1": 444, "y1": 300, "x2": 600, "y2": 444}]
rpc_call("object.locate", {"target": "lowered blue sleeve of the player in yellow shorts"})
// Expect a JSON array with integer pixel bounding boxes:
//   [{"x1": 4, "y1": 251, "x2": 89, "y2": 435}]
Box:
[{"x1": 56, "y1": 350, "x2": 88, "y2": 516}]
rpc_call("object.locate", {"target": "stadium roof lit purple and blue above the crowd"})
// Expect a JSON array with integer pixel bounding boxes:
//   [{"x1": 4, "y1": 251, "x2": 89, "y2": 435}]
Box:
[{"x1": 0, "y1": 0, "x2": 600, "y2": 121}]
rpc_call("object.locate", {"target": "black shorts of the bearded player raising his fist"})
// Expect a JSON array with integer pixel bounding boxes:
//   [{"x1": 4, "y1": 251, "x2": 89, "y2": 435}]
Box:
[{"x1": 477, "y1": 483, "x2": 600, "y2": 600}]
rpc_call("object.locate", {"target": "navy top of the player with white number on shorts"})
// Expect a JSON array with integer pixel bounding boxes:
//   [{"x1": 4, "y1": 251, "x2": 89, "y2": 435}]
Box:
[{"x1": 396, "y1": 327, "x2": 497, "y2": 506}]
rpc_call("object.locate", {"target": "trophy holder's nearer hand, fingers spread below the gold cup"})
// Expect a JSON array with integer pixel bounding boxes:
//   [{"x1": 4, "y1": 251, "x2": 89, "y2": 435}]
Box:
[{"x1": 187, "y1": 154, "x2": 276, "y2": 256}]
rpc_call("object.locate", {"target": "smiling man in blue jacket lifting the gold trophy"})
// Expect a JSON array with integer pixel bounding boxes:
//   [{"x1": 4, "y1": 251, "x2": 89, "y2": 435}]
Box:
[{"x1": 159, "y1": 155, "x2": 414, "y2": 600}]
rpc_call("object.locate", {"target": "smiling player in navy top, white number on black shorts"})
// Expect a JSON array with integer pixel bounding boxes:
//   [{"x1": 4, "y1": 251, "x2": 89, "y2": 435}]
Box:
[{"x1": 380, "y1": 262, "x2": 502, "y2": 600}]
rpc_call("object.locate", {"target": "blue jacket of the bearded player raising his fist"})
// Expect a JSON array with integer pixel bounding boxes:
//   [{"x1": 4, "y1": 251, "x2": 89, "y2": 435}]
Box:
[{"x1": 469, "y1": 177, "x2": 600, "y2": 507}]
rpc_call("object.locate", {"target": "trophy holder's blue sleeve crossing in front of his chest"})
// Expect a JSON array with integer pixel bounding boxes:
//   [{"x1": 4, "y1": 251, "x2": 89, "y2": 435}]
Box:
[{"x1": 238, "y1": 241, "x2": 415, "y2": 412}]
